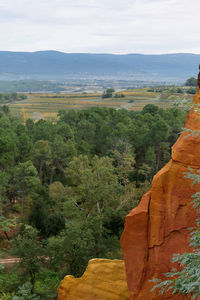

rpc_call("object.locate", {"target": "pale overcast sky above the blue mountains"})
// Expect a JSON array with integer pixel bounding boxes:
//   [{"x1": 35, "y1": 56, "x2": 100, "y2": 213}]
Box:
[{"x1": 0, "y1": 0, "x2": 200, "y2": 54}]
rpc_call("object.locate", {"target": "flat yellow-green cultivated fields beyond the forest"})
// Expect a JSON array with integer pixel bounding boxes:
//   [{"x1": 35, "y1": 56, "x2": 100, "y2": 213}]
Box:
[{"x1": 9, "y1": 88, "x2": 192, "y2": 120}]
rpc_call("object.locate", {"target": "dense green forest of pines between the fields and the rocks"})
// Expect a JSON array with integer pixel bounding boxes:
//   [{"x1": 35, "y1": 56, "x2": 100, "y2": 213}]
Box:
[{"x1": 0, "y1": 104, "x2": 186, "y2": 300}]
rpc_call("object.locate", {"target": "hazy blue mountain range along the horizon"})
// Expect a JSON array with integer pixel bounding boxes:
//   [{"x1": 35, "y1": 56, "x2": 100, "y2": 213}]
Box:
[{"x1": 0, "y1": 51, "x2": 200, "y2": 82}]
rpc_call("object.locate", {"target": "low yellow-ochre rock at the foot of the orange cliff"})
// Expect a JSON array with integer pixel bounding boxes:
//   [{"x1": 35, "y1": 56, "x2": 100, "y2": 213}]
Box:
[{"x1": 58, "y1": 259, "x2": 129, "y2": 300}]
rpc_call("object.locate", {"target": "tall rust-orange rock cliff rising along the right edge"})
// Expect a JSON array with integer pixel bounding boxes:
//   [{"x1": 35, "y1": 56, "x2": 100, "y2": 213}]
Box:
[{"x1": 121, "y1": 88, "x2": 200, "y2": 300}]
